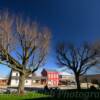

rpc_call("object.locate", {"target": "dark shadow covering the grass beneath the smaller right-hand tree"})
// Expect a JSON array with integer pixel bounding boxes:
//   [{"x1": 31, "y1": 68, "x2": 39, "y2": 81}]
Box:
[{"x1": 24, "y1": 89, "x2": 100, "y2": 100}]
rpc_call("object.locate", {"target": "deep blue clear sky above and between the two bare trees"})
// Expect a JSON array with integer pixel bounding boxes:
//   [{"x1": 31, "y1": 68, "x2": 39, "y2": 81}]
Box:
[{"x1": 0, "y1": 0, "x2": 100, "y2": 75}]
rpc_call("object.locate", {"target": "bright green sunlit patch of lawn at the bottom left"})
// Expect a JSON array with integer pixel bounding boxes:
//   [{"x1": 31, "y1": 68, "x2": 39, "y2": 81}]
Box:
[{"x1": 0, "y1": 93, "x2": 51, "y2": 100}]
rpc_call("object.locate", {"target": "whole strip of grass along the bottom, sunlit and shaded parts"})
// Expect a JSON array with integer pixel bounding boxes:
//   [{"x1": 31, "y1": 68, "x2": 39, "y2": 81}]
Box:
[{"x1": 0, "y1": 90, "x2": 100, "y2": 100}]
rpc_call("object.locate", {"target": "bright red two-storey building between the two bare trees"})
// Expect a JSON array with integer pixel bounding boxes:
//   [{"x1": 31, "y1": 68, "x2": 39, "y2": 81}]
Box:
[{"x1": 41, "y1": 69, "x2": 59, "y2": 86}]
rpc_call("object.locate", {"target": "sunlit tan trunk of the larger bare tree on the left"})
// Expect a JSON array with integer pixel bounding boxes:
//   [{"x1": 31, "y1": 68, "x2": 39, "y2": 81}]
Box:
[{"x1": 18, "y1": 73, "x2": 25, "y2": 94}]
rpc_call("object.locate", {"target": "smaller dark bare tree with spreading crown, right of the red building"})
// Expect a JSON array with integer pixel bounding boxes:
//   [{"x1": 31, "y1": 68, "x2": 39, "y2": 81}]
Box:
[{"x1": 56, "y1": 43, "x2": 100, "y2": 89}]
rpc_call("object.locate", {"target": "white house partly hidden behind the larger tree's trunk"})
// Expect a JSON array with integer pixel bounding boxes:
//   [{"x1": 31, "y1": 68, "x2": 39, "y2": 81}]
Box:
[{"x1": 10, "y1": 71, "x2": 32, "y2": 87}]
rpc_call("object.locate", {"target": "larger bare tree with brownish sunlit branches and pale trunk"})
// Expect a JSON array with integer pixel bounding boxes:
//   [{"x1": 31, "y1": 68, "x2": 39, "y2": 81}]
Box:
[{"x1": 0, "y1": 12, "x2": 50, "y2": 93}]
